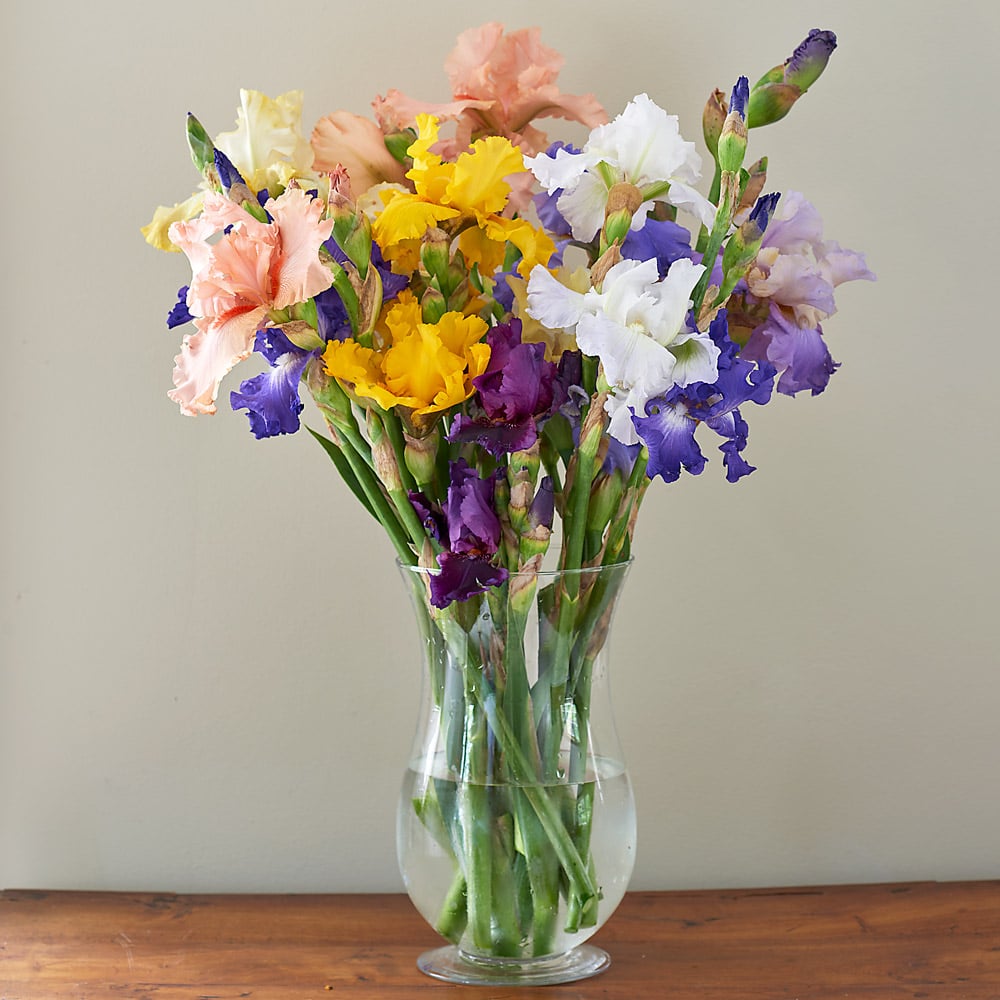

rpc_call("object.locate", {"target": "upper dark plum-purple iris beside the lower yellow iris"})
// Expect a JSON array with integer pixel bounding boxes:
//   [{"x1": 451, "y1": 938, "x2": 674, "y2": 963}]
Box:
[{"x1": 448, "y1": 319, "x2": 561, "y2": 456}]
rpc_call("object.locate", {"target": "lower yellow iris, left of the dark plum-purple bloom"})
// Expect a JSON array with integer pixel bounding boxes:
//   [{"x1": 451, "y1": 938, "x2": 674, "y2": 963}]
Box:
[{"x1": 323, "y1": 292, "x2": 490, "y2": 417}]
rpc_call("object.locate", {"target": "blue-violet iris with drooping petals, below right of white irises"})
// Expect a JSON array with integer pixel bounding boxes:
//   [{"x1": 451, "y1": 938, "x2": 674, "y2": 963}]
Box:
[{"x1": 632, "y1": 310, "x2": 776, "y2": 483}]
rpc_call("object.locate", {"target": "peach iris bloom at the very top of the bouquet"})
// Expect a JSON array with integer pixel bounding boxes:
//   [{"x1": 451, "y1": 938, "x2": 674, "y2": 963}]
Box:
[{"x1": 374, "y1": 21, "x2": 608, "y2": 157}]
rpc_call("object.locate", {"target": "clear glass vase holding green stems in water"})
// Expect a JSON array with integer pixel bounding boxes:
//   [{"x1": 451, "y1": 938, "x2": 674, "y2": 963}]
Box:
[{"x1": 397, "y1": 563, "x2": 635, "y2": 985}]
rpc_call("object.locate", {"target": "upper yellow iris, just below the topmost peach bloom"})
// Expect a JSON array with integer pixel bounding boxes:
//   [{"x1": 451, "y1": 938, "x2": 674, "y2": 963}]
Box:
[{"x1": 373, "y1": 115, "x2": 555, "y2": 278}]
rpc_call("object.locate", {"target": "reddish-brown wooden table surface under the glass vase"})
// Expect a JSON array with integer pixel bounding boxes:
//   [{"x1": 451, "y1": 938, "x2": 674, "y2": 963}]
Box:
[{"x1": 0, "y1": 881, "x2": 1000, "y2": 1000}]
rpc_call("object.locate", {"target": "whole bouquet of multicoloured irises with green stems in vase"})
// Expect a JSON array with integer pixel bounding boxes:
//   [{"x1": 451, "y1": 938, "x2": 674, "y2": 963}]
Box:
[{"x1": 144, "y1": 24, "x2": 873, "y2": 954}]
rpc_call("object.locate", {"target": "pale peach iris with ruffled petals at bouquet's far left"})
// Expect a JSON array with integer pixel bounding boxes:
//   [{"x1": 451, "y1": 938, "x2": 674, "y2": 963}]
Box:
[{"x1": 168, "y1": 187, "x2": 333, "y2": 416}]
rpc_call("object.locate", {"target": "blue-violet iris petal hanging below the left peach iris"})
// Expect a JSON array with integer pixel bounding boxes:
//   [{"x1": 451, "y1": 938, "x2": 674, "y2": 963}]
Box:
[{"x1": 229, "y1": 327, "x2": 312, "y2": 440}]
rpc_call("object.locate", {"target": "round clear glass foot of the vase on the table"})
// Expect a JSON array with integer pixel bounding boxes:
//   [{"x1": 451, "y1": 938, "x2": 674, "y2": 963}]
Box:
[{"x1": 417, "y1": 944, "x2": 611, "y2": 986}]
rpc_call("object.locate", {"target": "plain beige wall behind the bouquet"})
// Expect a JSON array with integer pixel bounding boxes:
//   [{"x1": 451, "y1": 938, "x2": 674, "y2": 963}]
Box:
[{"x1": 0, "y1": 0, "x2": 1000, "y2": 891}]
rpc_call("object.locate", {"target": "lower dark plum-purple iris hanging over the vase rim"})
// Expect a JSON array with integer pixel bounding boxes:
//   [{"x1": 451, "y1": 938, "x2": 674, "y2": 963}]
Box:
[{"x1": 428, "y1": 459, "x2": 507, "y2": 608}]
